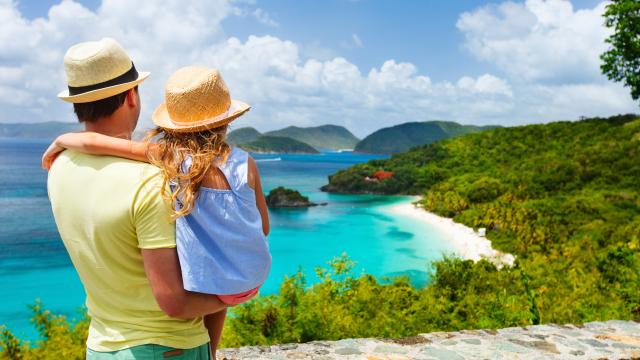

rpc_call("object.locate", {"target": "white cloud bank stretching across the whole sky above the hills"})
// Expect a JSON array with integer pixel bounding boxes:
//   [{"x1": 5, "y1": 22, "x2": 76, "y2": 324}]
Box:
[{"x1": 0, "y1": 0, "x2": 636, "y2": 136}]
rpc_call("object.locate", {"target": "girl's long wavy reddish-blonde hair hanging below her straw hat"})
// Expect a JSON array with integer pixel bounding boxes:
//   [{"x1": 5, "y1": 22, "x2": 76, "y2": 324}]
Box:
[{"x1": 146, "y1": 125, "x2": 231, "y2": 219}]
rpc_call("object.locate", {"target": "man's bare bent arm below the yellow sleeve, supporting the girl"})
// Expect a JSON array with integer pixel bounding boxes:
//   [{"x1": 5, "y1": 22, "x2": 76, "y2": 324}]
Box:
[{"x1": 142, "y1": 248, "x2": 227, "y2": 319}]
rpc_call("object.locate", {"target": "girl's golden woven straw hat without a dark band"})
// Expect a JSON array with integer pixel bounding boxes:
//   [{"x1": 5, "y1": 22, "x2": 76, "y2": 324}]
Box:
[{"x1": 151, "y1": 66, "x2": 251, "y2": 132}]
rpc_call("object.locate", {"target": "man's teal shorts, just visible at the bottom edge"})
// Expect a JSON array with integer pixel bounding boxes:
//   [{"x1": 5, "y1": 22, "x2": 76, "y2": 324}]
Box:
[{"x1": 87, "y1": 343, "x2": 213, "y2": 360}]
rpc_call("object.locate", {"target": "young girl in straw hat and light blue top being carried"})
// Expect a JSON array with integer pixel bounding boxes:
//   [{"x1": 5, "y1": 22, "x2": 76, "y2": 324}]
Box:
[{"x1": 43, "y1": 67, "x2": 271, "y2": 358}]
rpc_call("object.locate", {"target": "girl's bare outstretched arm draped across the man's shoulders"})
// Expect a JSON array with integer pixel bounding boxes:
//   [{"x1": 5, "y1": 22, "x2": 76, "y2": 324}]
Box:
[{"x1": 42, "y1": 132, "x2": 155, "y2": 169}]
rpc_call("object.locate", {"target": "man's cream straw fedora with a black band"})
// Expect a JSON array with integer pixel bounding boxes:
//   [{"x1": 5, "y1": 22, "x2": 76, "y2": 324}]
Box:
[{"x1": 58, "y1": 38, "x2": 149, "y2": 103}]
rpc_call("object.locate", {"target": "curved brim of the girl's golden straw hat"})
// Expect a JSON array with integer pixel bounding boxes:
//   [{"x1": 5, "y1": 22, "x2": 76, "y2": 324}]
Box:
[{"x1": 151, "y1": 100, "x2": 251, "y2": 132}]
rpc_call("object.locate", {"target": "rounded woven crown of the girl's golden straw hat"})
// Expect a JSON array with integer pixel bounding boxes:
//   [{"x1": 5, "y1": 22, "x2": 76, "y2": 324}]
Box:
[{"x1": 165, "y1": 66, "x2": 231, "y2": 124}]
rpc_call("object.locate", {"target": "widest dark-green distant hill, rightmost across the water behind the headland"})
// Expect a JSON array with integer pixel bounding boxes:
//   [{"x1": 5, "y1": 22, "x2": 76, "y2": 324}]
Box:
[{"x1": 355, "y1": 121, "x2": 499, "y2": 154}]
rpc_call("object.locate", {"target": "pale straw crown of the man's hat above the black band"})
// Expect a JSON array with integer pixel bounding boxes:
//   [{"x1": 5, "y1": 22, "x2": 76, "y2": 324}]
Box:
[{"x1": 64, "y1": 38, "x2": 132, "y2": 87}]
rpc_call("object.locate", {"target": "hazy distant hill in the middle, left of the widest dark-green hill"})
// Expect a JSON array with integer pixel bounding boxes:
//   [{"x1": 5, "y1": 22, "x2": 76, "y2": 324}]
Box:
[{"x1": 264, "y1": 125, "x2": 358, "y2": 150}]
